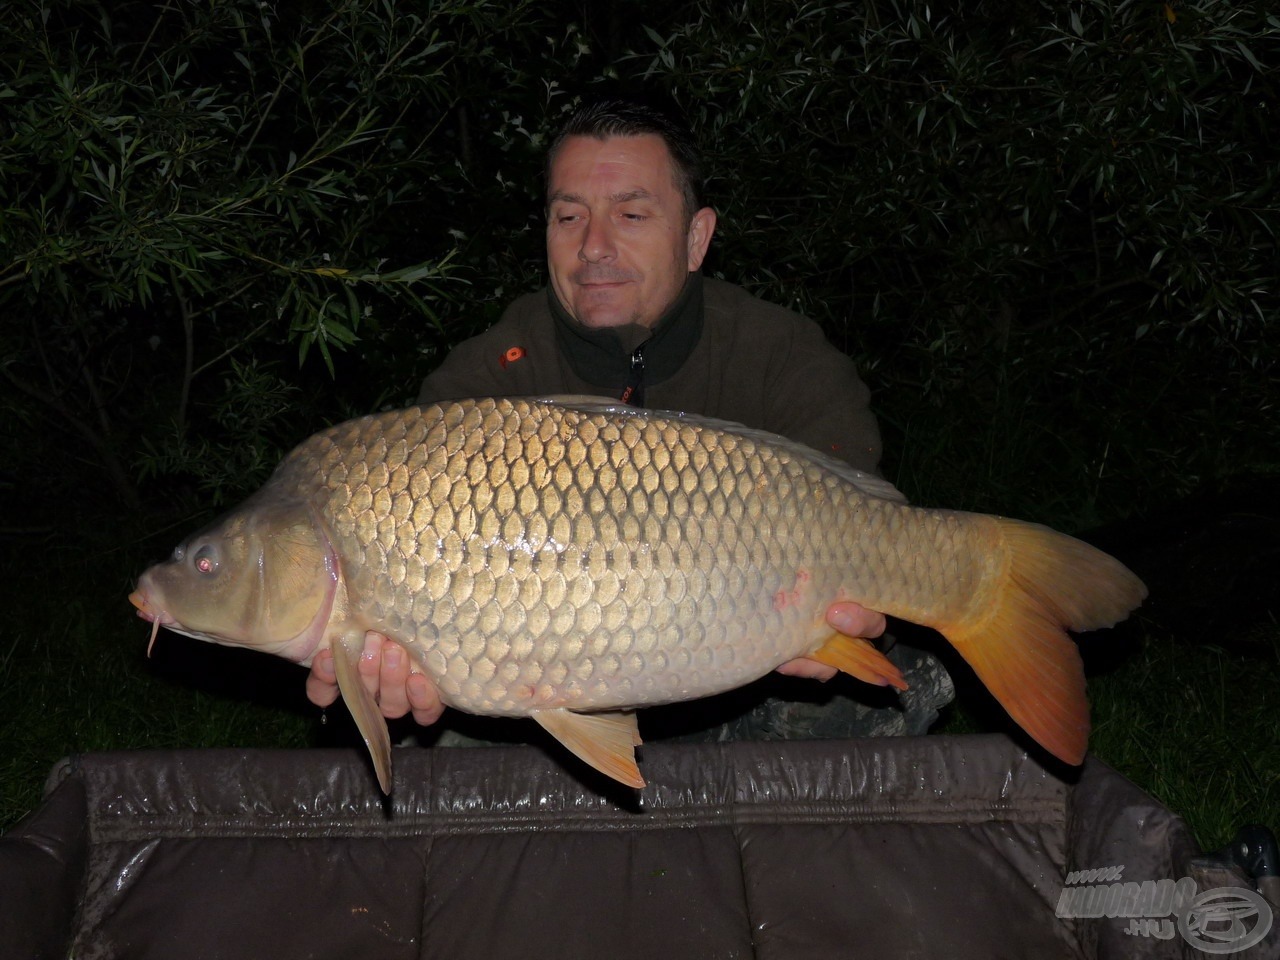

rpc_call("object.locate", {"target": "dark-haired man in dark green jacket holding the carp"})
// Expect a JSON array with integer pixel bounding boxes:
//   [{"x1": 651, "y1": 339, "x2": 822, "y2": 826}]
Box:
[{"x1": 307, "y1": 101, "x2": 916, "y2": 724}]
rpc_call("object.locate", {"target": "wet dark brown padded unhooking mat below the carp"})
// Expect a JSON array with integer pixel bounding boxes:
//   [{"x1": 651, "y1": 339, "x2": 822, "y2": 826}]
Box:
[{"x1": 0, "y1": 736, "x2": 1280, "y2": 960}]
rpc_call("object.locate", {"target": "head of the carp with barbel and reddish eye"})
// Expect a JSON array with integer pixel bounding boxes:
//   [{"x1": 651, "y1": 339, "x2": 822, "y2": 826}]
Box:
[{"x1": 129, "y1": 495, "x2": 340, "y2": 663}]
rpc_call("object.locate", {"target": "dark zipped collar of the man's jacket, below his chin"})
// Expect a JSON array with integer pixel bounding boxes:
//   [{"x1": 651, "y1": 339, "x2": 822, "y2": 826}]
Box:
[{"x1": 547, "y1": 271, "x2": 703, "y2": 388}]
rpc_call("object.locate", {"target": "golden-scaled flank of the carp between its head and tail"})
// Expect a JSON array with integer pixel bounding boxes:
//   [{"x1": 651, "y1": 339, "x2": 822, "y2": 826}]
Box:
[{"x1": 280, "y1": 399, "x2": 977, "y2": 716}]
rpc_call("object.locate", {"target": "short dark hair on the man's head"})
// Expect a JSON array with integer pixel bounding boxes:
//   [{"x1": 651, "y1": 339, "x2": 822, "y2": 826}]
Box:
[{"x1": 544, "y1": 97, "x2": 705, "y2": 225}]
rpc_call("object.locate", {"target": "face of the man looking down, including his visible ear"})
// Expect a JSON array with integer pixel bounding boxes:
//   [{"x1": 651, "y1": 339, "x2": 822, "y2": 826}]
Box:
[{"x1": 547, "y1": 134, "x2": 716, "y2": 328}]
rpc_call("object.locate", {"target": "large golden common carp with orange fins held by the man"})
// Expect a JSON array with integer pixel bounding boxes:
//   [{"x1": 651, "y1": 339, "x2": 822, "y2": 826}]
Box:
[{"x1": 129, "y1": 398, "x2": 1146, "y2": 791}]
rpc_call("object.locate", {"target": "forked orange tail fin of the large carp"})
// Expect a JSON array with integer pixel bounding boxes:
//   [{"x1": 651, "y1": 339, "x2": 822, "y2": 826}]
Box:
[{"x1": 934, "y1": 517, "x2": 1147, "y2": 764}]
